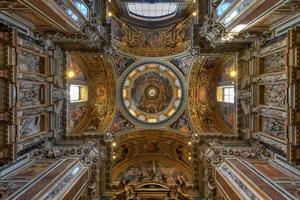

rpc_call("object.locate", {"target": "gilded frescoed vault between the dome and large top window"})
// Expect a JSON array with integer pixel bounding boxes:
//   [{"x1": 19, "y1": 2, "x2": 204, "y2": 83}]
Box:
[{"x1": 112, "y1": 19, "x2": 192, "y2": 56}]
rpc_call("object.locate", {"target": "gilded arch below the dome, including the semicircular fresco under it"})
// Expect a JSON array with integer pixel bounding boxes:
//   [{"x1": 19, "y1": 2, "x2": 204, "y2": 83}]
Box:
[{"x1": 110, "y1": 130, "x2": 196, "y2": 187}]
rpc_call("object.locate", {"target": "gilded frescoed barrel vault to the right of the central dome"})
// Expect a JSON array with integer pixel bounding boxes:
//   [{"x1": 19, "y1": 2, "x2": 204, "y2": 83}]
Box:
[{"x1": 189, "y1": 56, "x2": 236, "y2": 134}]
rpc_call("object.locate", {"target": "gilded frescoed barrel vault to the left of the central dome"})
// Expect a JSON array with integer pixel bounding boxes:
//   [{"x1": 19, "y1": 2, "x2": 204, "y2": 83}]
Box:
[{"x1": 68, "y1": 53, "x2": 116, "y2": 136}]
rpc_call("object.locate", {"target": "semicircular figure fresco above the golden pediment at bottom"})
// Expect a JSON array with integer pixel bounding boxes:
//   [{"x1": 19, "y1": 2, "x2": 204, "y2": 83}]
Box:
[{"x1": 115, "y1": 161, "x2": 188, "y2": 186}]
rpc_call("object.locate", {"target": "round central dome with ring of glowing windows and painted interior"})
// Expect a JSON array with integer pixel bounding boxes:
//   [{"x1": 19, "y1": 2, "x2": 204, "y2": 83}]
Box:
[{"x1": 121, "y1": 62, "x2": 183, "y2": 124}]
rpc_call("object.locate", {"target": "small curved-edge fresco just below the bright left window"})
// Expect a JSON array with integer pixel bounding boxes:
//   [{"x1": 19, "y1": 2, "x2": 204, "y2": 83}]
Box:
[{"x1": 68, "y1": 102, "x2": 88, "y2": 128}]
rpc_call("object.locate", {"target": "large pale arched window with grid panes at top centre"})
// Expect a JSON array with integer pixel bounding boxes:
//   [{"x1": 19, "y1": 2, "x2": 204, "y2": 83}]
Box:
[{"x1": 126, "y1": 2, "x2": 178, "y2": 20}]
